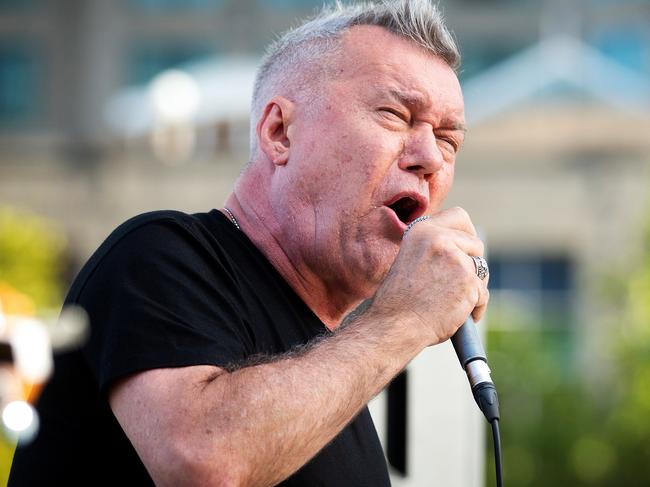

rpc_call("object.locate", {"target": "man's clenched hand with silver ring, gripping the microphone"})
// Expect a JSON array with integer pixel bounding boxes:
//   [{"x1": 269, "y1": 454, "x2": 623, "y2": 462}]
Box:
[{"x1": 373, "y1": 208, "x2": 489, "y2": 348}]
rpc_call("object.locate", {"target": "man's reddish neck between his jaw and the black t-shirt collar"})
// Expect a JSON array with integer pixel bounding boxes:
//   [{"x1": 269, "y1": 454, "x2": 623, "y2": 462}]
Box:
[{"x1": 222, "y1": 191, "x2": 364, "y2": 330}]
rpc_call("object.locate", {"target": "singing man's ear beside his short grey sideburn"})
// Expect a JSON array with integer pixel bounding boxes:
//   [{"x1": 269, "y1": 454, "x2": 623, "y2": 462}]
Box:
[{"x1": 257, "y1": 96, "x2": 294, "y2": 166}]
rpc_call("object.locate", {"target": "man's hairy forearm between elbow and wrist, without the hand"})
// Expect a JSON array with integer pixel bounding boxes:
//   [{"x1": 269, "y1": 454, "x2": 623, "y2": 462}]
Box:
[{"x1": 146, "y1": 316, "x2": 422, "y2": 486}]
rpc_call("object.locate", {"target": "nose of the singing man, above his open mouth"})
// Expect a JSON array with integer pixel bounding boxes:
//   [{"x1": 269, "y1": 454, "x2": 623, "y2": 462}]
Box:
[{"x1": 398, "y1": 123, "x2": 445, "y2": 181}]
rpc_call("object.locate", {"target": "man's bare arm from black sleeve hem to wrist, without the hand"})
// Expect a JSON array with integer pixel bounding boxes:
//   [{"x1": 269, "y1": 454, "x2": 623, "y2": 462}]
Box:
[{"x1": 111, "y1": 312, "x2": 420, "y2": 486}]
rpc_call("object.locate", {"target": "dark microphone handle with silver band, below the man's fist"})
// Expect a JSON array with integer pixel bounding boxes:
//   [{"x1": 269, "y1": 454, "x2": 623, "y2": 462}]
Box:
[{"x1": 451, "y1": 317, "x2": 499, "y2": 423}]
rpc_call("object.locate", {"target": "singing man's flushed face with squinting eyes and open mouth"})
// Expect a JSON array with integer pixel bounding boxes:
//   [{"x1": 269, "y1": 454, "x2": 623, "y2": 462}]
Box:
[{"x1": 272, "y1": 26, "x2": 464, "y2": 297}]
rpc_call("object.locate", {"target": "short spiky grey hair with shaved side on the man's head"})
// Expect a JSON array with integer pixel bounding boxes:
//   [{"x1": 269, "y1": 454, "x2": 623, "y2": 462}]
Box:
[{"x1": 250, "y1": 0, "x2": 460, "y2": 157}]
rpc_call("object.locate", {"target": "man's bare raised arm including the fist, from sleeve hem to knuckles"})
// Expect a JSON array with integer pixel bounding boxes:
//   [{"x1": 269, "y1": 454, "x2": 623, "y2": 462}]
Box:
[{"x1": 110, "y1": 207, "x2": 487, "y2": 486}]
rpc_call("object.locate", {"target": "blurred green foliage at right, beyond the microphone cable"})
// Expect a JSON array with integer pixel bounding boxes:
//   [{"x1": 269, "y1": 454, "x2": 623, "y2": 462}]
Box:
[{"x1": 486, "y1": 215, "x2": 650, "y2": 487}]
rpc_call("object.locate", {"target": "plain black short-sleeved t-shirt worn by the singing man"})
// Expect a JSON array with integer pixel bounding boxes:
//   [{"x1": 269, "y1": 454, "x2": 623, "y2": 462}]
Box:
[{"x1": 9, "y1": 210, "x2": 390, "y2": 487}]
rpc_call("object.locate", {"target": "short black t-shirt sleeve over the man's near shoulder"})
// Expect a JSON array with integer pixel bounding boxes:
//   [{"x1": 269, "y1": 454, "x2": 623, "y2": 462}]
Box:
[{"x1": 76, "y1": 219, "x2": 252, "y2": 392}]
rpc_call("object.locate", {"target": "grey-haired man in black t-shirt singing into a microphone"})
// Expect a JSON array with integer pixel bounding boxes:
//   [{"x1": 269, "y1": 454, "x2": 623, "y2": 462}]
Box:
[{"x1": 10, "y1": 0, "x2": 488, "y2": 487}]
